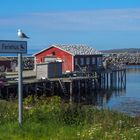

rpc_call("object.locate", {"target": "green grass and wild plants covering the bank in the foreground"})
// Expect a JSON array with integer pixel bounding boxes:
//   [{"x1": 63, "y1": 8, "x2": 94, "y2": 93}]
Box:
[{"x1": 0, "y1": 95, "x2": 140, "y2": 140}]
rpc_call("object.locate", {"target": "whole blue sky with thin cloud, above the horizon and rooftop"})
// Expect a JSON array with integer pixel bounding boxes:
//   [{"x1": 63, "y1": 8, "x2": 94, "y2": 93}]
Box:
[{"x1": 0, "y1": 0, "x2": 140, "y2": 50}]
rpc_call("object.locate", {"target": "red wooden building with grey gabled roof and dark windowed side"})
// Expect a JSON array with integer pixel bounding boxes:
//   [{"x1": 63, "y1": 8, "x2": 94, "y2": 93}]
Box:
[{"x1": 34, "y1": 45, "x2": 102, "y2": 72}]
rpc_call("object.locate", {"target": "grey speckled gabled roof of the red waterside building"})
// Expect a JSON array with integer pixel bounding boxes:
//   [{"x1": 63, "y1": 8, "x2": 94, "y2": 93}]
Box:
[{"x1": 34, "y1": 45, "x2": 101, "y2": 56}]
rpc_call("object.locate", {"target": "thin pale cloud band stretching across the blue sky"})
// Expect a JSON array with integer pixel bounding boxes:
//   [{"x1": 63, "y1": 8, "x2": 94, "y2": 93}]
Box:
[{"x1": 0, "y1": 9, "x2": 140, "y2": 31}]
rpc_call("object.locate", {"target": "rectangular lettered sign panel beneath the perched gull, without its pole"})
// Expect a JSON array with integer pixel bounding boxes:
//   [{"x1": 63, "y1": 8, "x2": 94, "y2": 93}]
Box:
[{"x1": 0, "y1": 40, "x2": 27, "y2": 53}]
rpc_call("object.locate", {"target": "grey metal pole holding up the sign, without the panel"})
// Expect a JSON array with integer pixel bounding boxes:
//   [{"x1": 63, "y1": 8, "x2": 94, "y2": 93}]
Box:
[{"x1": 18, "y1": 53, "x2": 23, "y2": 125}]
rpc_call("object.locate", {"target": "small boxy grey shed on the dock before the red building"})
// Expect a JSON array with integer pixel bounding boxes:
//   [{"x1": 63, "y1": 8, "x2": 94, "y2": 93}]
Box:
[{"x1": 36, "y1": 61, "x2": 62, "y2": 79}]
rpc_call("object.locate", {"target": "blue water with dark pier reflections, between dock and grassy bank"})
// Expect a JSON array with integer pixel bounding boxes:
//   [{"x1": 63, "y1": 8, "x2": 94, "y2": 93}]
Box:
[{"x1": 75, "y1": 66, "x2": 140, "y2": 116}]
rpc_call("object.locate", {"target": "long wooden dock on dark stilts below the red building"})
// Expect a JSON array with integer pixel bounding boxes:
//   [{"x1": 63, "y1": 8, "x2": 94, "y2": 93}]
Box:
[{"x1": 0, "y1": 69, "x2": 126, "y2": 102}]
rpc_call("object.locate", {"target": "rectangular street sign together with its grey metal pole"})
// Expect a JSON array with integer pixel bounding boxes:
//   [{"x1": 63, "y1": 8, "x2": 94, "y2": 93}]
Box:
[{"x1": 0, "y1": 40, "x2": 27, "y2": 125}]
